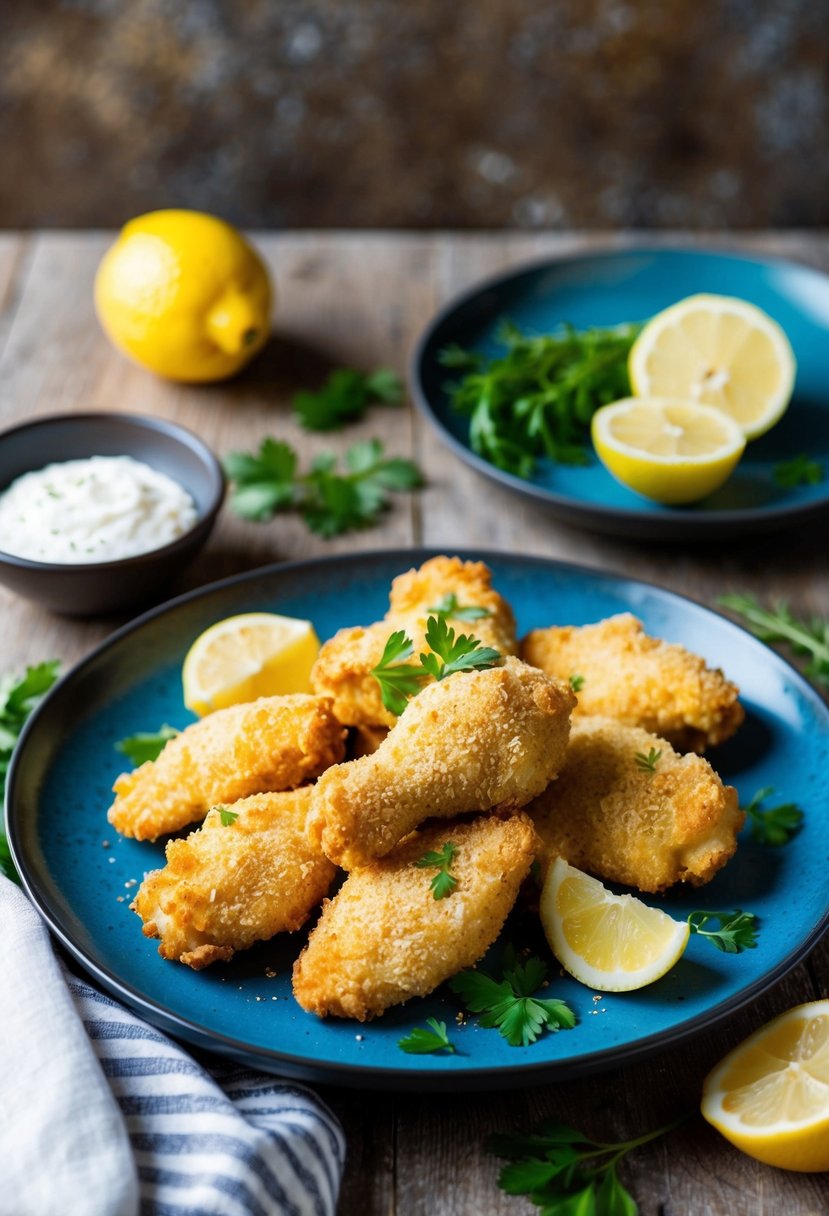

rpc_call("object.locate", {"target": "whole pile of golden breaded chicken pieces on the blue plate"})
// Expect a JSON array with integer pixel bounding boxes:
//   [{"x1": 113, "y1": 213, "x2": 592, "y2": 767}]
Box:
[{"x1": 109, "y1": 557, "x2": 744, "y2": 1021}]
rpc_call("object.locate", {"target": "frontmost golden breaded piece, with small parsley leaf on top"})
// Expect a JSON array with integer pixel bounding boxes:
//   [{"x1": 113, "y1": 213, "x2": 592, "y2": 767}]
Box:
[{"x1": 294, "y1": 812, "x2": 535, "y2": 1021}]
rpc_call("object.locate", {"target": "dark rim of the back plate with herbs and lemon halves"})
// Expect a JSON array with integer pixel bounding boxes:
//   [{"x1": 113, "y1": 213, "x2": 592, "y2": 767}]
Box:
[{"x1": 407, "y1": 244, "x2": 829, "y2": 539}]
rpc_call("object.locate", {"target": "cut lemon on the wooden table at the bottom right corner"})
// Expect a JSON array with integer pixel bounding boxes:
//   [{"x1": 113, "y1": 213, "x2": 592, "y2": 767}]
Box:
[{"x1": 701, "y1": 1001, "x2": 829, "y2": 1171}]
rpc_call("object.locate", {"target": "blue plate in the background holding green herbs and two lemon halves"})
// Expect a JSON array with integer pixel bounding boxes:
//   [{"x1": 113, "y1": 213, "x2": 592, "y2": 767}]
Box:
[{"x1": 410, "y1": 249, "x2": 829, "y2": 540}]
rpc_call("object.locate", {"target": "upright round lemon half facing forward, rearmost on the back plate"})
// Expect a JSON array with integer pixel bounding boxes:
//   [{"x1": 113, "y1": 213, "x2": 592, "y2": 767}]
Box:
[{"x1": 627, "y1": 295, "x2": 796, "y2": 439}]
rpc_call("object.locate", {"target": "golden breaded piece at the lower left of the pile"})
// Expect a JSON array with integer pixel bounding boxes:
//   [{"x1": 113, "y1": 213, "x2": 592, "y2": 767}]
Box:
[{"x1": 131, "y1": 787, "x2": 337, "y2": 970}]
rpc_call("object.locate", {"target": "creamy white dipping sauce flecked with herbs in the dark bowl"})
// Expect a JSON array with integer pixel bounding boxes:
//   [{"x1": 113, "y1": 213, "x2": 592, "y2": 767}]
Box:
[{"x1": 0, "y1": 456, "x2": 197, "y2": 565}]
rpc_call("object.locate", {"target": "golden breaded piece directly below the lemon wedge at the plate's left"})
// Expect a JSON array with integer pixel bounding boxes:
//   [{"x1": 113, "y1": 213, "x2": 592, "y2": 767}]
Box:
[{"x1": 107, "y1": 693, "x2": 345, "y2": 840}]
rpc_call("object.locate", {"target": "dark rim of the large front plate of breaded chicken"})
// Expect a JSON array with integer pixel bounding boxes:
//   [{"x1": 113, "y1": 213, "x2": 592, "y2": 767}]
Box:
[{"x1": 5, "y1": 546, "x2": 829, "y2": 1093}]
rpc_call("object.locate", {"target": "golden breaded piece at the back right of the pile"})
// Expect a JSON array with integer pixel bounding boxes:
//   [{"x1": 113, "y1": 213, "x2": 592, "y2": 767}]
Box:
[{"x1": 520, "y1": 613, "x2": 745, "y2": 751}]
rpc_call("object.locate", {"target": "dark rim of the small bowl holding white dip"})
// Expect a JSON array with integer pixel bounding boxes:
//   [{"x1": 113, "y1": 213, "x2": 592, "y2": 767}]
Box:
[{"x1": 0, "y1": 410, "x2": 227, "y2": 575}]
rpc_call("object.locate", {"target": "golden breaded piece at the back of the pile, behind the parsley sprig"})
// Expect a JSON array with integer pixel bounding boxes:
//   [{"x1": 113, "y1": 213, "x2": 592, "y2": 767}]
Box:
[{"x1": 311, "y1": 557, "x2": 518, "y2": 726}]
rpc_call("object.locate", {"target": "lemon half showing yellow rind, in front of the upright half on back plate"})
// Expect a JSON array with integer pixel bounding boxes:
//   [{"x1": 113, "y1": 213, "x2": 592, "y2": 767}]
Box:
[{"x1": 591, "y1": 396, "x2": 745, "y2": 503}]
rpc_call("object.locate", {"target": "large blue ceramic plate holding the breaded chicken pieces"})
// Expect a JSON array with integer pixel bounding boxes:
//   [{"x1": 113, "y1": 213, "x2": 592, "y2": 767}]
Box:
[{"x1": 9, "y1": 551, "x2": 829, "y2": 1090}]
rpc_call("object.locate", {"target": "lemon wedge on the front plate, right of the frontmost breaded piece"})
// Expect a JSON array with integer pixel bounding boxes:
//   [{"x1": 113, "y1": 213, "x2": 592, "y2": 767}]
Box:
[{"x1": 541, "y1": 857, "x2": 690, "y2": 992}]
